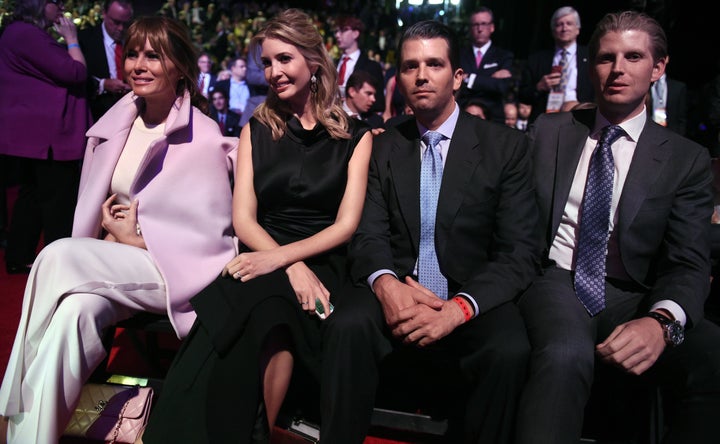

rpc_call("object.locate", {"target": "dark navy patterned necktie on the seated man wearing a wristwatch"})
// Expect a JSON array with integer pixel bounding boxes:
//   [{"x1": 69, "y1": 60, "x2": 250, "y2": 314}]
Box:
[{"x1": 575, "y1": 125, "x2": 625, "y2": 316}]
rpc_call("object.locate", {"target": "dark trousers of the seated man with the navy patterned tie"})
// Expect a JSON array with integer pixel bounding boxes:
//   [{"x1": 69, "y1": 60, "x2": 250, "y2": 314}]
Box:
[{"x1": 517, "y1": 268, "x2": 720, "y2": 444}]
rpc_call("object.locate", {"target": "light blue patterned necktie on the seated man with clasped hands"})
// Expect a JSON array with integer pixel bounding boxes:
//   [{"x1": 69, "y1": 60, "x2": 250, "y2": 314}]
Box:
[{"x1": 418, "y1": 131, "x2": 447, "y2": 299}]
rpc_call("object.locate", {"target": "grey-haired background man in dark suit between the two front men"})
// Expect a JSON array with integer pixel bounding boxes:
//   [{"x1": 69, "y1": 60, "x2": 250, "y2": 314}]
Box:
[{"x1": 519, "y1": 6, "x2": 594, "y2": 122}]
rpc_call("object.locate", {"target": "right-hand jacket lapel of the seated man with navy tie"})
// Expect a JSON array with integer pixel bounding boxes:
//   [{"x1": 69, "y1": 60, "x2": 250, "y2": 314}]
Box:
[{"x1": 618, "y1": 123, "x2": 670, "y2": 230}]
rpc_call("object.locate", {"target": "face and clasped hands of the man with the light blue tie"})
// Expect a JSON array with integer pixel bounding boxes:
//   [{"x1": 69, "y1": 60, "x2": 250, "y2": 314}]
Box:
[{"x1": 373, "y1": 38, "x2": 472, "y2": 347}]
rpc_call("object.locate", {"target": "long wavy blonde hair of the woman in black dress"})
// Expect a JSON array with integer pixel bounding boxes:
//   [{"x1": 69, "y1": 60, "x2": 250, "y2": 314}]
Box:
[{"x1": 250, "y1": 9, "x2": 350, "y2": 140}]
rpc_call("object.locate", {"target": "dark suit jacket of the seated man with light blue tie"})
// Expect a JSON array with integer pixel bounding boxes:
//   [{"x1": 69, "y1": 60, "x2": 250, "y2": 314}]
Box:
[{"x1": 349, "y1": 112, "x2": 537, "y2": 312}]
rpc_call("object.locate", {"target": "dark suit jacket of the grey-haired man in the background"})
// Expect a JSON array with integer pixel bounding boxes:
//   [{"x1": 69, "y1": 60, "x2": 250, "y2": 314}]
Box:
[{"x1": 519, "y1": 45, "x2": 595, "y2": 122}]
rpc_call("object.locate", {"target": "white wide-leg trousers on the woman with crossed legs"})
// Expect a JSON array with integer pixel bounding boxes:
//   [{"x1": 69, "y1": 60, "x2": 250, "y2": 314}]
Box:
[{"x1": 0, "y1": 238, "x2": 167, "y2": 444}]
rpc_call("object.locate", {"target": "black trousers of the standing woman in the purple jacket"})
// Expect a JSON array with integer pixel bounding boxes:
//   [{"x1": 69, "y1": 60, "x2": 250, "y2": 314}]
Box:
[{"x1": 5, "y1": 154, "x2": 79, "y2": 265}]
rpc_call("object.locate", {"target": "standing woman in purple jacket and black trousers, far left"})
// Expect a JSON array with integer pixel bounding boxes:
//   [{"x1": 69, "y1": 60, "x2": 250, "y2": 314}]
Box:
[{"x1": 0, "y1": 0, "x2": 91, "y2": 273}]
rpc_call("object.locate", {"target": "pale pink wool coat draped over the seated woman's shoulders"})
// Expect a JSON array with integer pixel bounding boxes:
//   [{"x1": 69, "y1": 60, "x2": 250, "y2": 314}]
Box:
[{"x1": 72, "y1": 93, "x2": 237, "y2": 338}]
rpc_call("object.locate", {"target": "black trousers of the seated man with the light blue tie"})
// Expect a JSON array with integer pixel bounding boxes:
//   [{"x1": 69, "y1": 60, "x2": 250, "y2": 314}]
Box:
[{"x1": 320, "y1": 287, "x2": 529, "y2": 444}]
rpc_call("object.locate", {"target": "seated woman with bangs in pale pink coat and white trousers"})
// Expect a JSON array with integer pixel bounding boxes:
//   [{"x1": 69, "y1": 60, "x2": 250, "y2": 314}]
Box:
[{"x1": 0, "y1": 17, "x2": 237, "y2": 443}]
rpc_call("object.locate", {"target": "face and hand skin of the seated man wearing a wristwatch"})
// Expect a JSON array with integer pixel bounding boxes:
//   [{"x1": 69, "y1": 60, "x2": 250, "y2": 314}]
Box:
[{"x1": 590, "y1": 31, "x2": 672, "y2": 375}]
